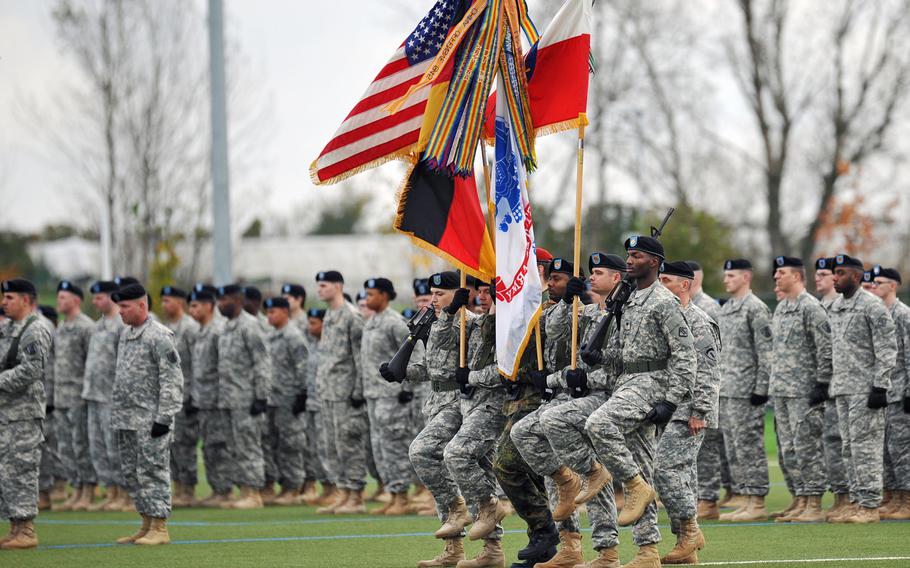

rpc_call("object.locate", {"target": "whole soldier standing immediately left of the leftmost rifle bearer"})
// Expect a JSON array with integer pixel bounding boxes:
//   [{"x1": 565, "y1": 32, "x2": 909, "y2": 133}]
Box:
[{"x1": 360, "y1": 278, "x2": 423, "y2": 515}]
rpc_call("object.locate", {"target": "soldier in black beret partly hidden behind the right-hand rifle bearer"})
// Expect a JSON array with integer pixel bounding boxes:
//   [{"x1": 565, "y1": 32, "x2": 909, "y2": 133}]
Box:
[{"x1": 654, "y1": 262, "x2": 721, "y2": 564}]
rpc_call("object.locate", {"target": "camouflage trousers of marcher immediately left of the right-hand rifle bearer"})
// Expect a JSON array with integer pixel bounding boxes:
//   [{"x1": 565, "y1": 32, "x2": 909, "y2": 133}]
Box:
[{"x1": 540, "y1": 391, "x2": 624, "y2": 550}]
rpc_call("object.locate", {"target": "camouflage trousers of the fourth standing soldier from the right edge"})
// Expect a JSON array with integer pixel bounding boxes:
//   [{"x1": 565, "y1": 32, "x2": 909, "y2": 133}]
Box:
[{"x1": 774, "y1": 398, "x2": 828, "y2": 496}]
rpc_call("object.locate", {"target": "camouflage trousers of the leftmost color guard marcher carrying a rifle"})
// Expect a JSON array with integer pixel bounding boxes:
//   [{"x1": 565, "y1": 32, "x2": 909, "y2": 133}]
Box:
[{"x1": 408, "y1": 402, "x2": 461, "y2": 522}]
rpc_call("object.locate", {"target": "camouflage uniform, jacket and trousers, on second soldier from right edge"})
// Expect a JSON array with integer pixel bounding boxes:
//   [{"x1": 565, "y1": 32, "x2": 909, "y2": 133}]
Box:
[{"x1": 828, "y1": 289, "x2": 897, "y2": 508}]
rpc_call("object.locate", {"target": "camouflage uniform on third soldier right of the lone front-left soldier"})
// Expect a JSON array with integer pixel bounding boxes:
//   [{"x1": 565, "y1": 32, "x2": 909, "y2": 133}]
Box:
[{"x1": 218, "y1": 310, "x2": 272, "y2": 489}]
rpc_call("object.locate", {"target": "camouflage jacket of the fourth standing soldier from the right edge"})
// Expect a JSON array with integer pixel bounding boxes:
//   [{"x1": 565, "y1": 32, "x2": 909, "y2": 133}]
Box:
[{"x1": 768, "y1": 292, "x2": 831, "y2": 398}]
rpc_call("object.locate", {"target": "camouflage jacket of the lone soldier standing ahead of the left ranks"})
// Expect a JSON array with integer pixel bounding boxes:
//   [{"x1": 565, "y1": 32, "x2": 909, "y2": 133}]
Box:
[{"x1": 111, "y1": 318, "x2": 183, "y2": 430}]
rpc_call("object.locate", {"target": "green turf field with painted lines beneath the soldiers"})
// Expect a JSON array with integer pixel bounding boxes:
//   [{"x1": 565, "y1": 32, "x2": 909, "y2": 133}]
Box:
[{"x1": 7, "y1": 412, "x2": 910, "y2": 568}]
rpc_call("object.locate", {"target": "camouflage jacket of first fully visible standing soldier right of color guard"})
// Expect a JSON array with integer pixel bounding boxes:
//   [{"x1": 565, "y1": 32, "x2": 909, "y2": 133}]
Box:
[{"x1": 717, "y1": 292, "x2": 772, "y2": 398}]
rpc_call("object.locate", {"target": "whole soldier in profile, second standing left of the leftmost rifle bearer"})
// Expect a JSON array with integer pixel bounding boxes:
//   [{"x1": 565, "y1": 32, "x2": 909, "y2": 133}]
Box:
[{"x1": 316, "y1": 270, "x2": 369, "y2": 514}]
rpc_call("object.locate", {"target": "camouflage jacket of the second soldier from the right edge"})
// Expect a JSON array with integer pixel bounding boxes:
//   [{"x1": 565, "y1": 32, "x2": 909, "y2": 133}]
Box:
[{"x1": 828, "y1": 289, "x2": 897, "y2": 396}]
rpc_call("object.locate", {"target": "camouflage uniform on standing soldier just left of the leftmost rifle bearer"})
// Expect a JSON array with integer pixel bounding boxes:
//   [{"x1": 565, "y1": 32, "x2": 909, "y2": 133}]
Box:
[{"x1": 360, "y1": 309, "x2": 423, "y2": 493}]
